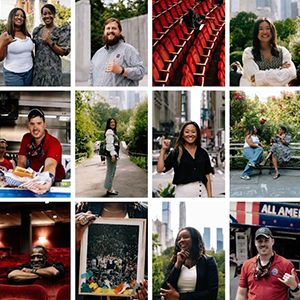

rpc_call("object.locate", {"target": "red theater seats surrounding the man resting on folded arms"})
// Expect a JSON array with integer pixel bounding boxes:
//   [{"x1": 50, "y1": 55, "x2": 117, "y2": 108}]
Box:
[{"x1": 0, "y1": 248, "x2": 70, "y2": 300}]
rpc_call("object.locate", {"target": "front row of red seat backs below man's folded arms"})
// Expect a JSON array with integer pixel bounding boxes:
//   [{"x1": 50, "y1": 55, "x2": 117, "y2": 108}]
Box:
[{"x1": 0, "y1": 284, "x2": 71, "y2": 300}]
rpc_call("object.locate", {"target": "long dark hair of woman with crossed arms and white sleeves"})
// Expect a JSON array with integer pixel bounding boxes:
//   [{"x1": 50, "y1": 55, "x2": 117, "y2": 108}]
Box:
[{"x1": 252, "y1": 17, "x2": 279, "y2": 61}]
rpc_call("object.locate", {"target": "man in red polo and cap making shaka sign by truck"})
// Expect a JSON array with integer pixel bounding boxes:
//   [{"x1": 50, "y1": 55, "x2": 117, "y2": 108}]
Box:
[{"x1": 235, "y1": 227, "x2": 300, "y2": 300}]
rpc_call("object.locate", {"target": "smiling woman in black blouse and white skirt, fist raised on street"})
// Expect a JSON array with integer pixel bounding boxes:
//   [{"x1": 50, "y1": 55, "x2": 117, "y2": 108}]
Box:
[{"x1": 157, "y1": 121, "x2": 212, "y2": 198}]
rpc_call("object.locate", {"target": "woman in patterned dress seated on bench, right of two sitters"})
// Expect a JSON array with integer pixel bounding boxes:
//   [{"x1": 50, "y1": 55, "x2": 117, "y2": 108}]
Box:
[{"x1": 260, "y1": 126, "x2": 292, "y2": 179}]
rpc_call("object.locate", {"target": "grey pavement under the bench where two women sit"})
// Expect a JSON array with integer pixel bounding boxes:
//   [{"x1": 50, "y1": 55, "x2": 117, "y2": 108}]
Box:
[{"x1": 230, "y1": 168, "x2": 300, "y2": 198}]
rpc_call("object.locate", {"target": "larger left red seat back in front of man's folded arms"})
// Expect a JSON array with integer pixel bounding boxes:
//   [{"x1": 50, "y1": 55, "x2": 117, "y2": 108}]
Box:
[{"x1": 0, "y1": 284, "x2": 48, "y2": 300}]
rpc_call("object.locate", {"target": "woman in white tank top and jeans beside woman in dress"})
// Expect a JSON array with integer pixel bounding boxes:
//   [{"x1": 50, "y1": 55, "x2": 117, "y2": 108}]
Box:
[{"x1": 0, "y1": 8, "x2": 34, "y2": 86}]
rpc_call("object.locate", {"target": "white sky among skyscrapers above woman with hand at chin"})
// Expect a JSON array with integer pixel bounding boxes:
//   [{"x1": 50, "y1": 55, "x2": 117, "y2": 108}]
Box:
[{"x1": 153, "y1": 202, "x2": 229, "y2": 250}]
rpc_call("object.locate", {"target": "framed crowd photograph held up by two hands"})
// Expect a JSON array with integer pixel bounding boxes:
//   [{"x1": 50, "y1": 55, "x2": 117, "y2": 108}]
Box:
[{"x1": 79, "y1": 218, "x2": 146, "y2": 297}]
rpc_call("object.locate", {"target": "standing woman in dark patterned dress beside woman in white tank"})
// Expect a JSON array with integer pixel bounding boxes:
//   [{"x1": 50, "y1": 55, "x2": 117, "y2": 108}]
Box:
[{"x1": 32, "y1": 4, "x2": 70, "y2": 86}]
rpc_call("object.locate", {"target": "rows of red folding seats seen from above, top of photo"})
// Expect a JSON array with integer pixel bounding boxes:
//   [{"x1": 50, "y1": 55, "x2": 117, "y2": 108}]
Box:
[{"x1": 152, "y1": 0, "x2": 225, "y2": 86}]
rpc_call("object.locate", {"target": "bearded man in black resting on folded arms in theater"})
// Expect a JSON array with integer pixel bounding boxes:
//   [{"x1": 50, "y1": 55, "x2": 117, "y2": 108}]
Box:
[{"x1": 7, "y1": 246, "x2": 65, "y2": 284}]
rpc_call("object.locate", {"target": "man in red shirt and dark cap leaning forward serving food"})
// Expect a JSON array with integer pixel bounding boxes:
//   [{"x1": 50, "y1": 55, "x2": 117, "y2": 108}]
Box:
[{"x1": 18, "y1": 108, "x2": 65, "y2": 194}]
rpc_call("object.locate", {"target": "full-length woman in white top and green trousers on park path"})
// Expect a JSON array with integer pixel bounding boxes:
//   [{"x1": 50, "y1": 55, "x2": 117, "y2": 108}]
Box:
[{"x1": 104, "y1": 118, "x2": 119, "y2": 196}]
